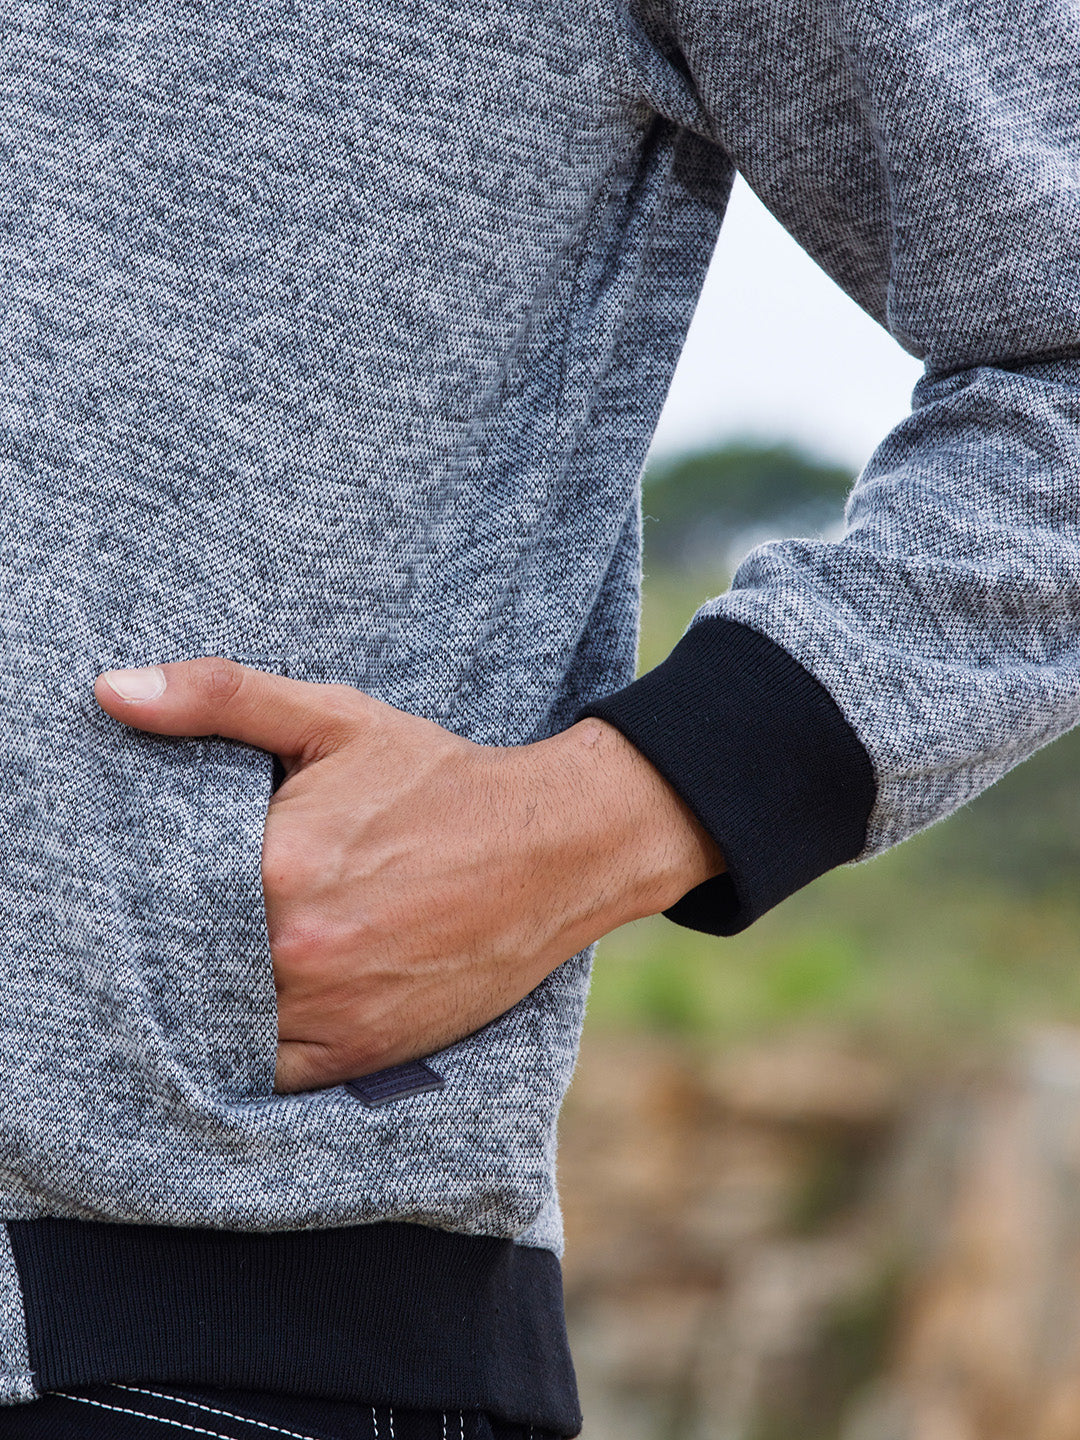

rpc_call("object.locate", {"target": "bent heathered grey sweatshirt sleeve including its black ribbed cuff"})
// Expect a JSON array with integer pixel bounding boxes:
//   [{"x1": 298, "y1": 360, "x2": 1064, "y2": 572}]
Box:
[{"x1": 589, "y1": 0, "x2": 1080, "y2": 933}]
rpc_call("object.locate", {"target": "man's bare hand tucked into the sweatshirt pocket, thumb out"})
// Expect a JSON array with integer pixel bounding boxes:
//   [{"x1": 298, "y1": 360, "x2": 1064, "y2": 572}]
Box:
[{"x1": 95, "y1": 658, "x2": 723, "y2": 1092}]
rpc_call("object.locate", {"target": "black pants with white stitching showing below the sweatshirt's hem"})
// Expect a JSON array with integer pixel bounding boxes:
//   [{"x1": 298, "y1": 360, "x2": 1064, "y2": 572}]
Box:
[{"x1": 0, "y1": 1384, "x2": 556, "y2": 1440}]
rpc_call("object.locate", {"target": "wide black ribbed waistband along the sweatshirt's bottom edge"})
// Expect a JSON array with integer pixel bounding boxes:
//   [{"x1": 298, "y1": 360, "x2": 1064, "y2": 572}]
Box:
[{"x1": 7, "y1": 1220, "x2": 582, "y2": 1436}]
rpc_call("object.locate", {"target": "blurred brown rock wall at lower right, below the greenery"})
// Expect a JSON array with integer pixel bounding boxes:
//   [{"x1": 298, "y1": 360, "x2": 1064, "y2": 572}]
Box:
[{"x1": 560, "y1": 1031, "x2": 1080, "y2": 1440}]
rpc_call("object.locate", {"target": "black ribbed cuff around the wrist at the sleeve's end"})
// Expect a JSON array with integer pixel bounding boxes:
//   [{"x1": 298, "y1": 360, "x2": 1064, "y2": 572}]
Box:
[{"x1": 580, "y1": 618, "x2": 877, "y2": 935}]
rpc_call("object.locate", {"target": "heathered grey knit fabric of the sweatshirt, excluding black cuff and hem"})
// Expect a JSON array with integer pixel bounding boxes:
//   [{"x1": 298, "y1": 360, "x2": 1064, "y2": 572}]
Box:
[{"x1": 0, "y1": 0, "x2": 1080, "y2": 1382}]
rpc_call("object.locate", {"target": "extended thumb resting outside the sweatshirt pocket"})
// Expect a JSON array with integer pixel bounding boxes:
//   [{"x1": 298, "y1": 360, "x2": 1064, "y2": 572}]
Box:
[{"x1": 94, "y1": 655, "x2": 360, "y2": 762}]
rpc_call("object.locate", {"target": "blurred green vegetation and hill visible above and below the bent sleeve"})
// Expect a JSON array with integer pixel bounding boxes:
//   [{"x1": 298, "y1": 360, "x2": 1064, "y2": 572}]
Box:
[{"x1": 590, "y1": 446, "x2": 1080, "y2": 1060}]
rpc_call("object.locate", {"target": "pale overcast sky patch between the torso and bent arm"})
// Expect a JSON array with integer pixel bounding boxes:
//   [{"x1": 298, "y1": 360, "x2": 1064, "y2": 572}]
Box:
[{"x1": 654, "y1": 180, "x2": 920, "y2": 469}]
